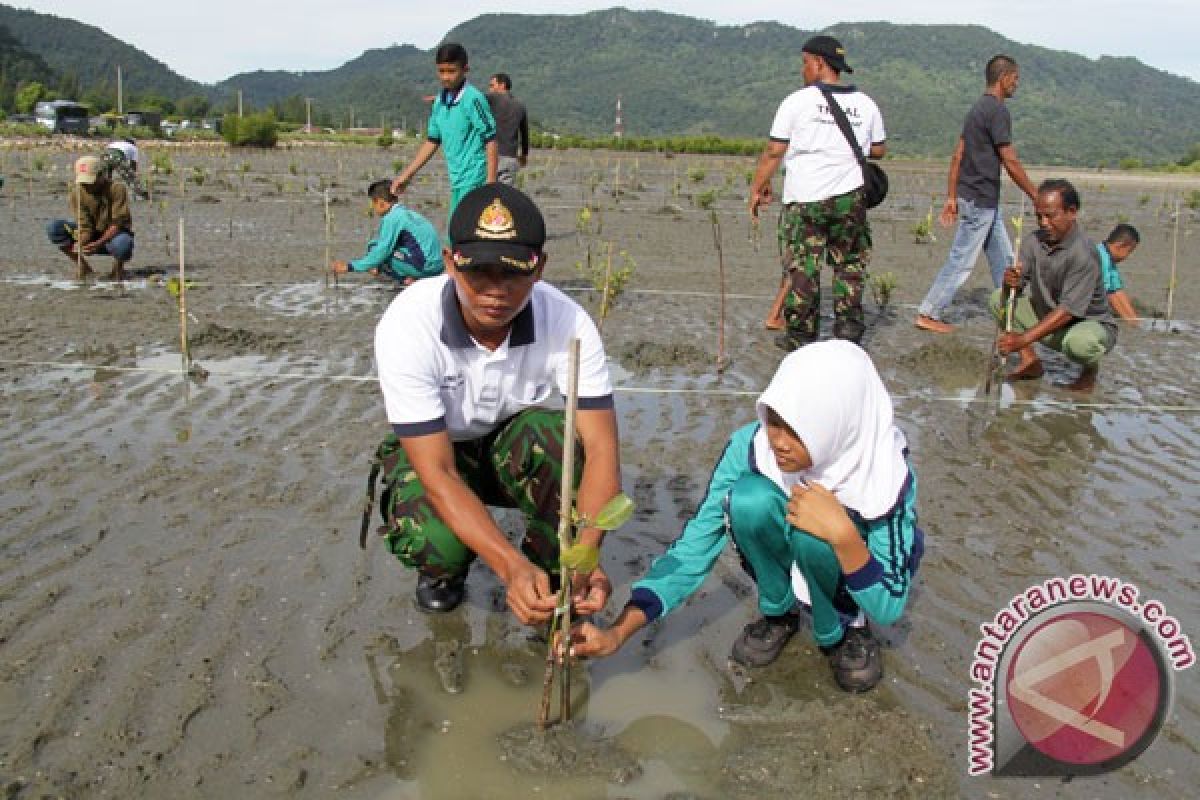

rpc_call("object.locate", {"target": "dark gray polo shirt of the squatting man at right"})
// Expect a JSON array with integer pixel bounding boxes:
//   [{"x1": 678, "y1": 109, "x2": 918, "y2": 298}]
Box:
[{"x1": 1021, "y1": 223, "x2": 1117, "y2": 344}]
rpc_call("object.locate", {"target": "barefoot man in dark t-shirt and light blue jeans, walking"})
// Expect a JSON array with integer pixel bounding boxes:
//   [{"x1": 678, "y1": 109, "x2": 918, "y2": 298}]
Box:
[{"x1": 916, "y1": 55, "x2": 1037, "y2": 333}]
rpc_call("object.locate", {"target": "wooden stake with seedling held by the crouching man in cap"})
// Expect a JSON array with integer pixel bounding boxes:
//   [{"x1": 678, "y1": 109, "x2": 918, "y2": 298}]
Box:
[{"x1": 538, "y1": 338, "x2": 580, "y2": 730}]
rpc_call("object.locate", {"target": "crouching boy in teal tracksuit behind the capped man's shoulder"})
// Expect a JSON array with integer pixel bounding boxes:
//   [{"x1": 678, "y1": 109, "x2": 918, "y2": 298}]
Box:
[{"x1": 331, "y1": 180, "x2": 443, "y2": 285}]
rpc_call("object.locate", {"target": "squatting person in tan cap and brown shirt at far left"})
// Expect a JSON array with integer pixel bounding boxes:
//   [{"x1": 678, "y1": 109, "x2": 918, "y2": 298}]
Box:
[{"x1": 46, "y1": 156, "x2": 133, "y2": 281}]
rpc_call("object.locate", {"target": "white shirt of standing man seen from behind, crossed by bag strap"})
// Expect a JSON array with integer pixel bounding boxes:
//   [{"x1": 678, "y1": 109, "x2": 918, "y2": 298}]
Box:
[{"x1": 770, "y1": 84, "x2": 887, "y2": 203}]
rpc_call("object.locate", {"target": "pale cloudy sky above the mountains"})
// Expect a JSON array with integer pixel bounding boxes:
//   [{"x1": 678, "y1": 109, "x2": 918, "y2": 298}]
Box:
[{"x1": 21, "y1": 0, "x2": 1200, "y2": 83}]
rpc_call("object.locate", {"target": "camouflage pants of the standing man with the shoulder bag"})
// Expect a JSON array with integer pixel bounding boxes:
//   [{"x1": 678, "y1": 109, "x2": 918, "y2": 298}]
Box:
[{"x1": 779, "y1": 190, "x2": 871, "y2": 348}]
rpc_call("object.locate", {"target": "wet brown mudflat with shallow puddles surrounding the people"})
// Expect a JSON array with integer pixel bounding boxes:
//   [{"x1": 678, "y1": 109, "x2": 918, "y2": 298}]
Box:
[{"x1": 0, "y1": 143, "x2": 1200, "y2": 798}]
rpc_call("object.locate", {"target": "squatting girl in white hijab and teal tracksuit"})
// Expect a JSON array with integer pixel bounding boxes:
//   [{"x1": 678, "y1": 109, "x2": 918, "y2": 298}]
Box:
[{"x1": 572, "y1": 339, "x2": 924, "y2": 692}]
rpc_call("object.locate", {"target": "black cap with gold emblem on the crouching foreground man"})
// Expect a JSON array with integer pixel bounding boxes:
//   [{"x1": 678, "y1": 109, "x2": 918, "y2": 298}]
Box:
[{"x1": 449, "y1": 184, "x2": 546, "y2": 275}]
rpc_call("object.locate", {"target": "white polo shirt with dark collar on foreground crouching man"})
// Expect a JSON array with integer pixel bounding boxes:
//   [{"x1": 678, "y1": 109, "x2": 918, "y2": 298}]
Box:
[{"x1": 376, "y1": 275, "x2": 612, "y2": 441}]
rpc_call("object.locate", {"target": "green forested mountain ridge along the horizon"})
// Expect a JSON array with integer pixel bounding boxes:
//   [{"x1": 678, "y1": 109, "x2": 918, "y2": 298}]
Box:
[{"x1": 0, "y1": 6, "x2": 1200, "y2": 164}]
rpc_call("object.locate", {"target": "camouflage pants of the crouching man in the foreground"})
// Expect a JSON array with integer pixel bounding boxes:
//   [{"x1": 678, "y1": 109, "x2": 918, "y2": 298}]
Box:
[{"x1": 379, "y1": 409, "x2": 583, "y2": 577}]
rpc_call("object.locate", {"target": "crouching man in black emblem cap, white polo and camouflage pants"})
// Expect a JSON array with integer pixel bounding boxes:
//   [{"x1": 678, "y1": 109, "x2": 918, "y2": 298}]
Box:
[{"x1": 376, "y1": 184, "x2": 620, "y2": 624}]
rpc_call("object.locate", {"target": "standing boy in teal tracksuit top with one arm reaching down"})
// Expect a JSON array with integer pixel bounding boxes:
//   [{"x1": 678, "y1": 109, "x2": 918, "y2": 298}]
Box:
[{"x1": 391, "y1": 43, "x2": 499, "y2": 216}]
